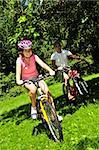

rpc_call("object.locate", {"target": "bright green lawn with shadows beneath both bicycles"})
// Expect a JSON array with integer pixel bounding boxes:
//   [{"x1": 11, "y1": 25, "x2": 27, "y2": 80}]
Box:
[{"x1": 0, "y1": 75, "x2": 99, "y2": 150}]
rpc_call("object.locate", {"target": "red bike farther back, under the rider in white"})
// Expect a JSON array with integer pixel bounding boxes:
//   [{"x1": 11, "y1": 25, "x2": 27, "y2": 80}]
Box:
[{"x1": 57, "y1": 67, "x2": 88, "y2": 100}]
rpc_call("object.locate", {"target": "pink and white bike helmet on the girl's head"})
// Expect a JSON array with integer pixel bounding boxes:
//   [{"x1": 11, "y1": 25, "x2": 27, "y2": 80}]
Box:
[{"x1": 18, "y1": 40, "x2": 32, "y2": 49}]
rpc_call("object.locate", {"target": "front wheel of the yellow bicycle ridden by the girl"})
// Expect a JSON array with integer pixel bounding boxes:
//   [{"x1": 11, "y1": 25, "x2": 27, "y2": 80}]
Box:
[{"x1": 42, "y1": 100, "x2": 63, "y2": 142}]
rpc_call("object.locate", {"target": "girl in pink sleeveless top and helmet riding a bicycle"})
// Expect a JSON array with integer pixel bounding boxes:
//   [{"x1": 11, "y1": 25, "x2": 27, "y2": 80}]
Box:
[{"x1": 16, "y1": 40, "x2": 55, "y2": 119}]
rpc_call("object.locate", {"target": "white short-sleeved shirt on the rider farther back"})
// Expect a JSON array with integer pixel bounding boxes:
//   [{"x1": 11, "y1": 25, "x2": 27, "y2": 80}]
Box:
[{"x1": 51, "y1": 50, "x2": 72, "y2": 67}]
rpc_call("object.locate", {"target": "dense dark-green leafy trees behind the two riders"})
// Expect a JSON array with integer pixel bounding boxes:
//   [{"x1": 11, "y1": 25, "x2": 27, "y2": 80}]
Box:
[{"x1": 0, "y1": 0, "x2": 99, "y2": 74}]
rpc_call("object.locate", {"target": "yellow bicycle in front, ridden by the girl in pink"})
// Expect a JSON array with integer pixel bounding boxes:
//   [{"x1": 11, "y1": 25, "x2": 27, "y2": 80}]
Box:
[{"x1": 24, "y1": 74, "x2": 63, "y2": 142}]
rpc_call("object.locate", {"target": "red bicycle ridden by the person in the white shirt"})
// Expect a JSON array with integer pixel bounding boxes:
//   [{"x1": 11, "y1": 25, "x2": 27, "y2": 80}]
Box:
[{"x1": 58, "y1": 66, "x2": 88, "y2": 103}]
